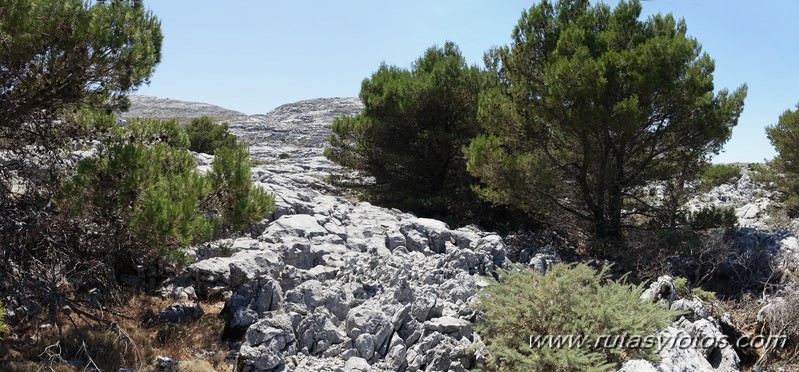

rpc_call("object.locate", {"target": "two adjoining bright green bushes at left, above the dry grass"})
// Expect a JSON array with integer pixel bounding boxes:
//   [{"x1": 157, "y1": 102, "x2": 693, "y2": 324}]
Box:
[{"x1": 60, "y1": 119, "x2": 274, "y2": 257}]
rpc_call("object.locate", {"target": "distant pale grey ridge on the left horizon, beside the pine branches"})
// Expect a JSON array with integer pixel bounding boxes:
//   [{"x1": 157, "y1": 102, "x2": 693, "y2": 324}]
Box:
[{"x1": 121, "y1": 95, "x2": 247, "y2": 120}]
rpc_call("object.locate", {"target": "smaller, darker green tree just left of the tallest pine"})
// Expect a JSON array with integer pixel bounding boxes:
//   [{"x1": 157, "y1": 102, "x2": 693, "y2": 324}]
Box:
[{"x1": 325, "y1": 42, "x2": 488, "y2": 223}]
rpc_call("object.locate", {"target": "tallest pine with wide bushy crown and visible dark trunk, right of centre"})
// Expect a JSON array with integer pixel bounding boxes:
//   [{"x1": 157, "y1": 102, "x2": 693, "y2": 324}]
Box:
[{"x1": 466, "y1": 0, "x2": 746, "y2": 242}]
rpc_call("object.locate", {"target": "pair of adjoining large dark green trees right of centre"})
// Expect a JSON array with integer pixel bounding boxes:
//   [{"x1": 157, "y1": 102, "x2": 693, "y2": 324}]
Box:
[{"x1": 325, "y1": 0, "x2": 747, "y2": 244}]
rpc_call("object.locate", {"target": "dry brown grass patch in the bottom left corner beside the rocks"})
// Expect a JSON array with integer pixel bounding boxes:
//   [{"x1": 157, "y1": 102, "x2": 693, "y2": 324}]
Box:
[{"x1": 0, "y1": 295, "x2": 233, "y2": 372}]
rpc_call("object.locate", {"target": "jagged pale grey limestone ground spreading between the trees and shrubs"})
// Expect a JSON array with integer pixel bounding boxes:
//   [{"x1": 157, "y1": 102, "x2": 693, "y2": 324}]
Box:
[{"x1": 132, "y1": 98, "x2": 799, "y2": 371}]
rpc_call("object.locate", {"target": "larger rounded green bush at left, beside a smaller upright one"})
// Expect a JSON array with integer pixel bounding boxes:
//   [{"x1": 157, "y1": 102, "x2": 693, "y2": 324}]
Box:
[{"x1": 62, "y1": 121, "x2": 213, "y2": 256}]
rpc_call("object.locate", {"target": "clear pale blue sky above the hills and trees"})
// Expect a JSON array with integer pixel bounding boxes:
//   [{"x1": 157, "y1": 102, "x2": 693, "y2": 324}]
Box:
[{"x1": 138, "y1": 0, "x2": 799, "y2": 163}]
